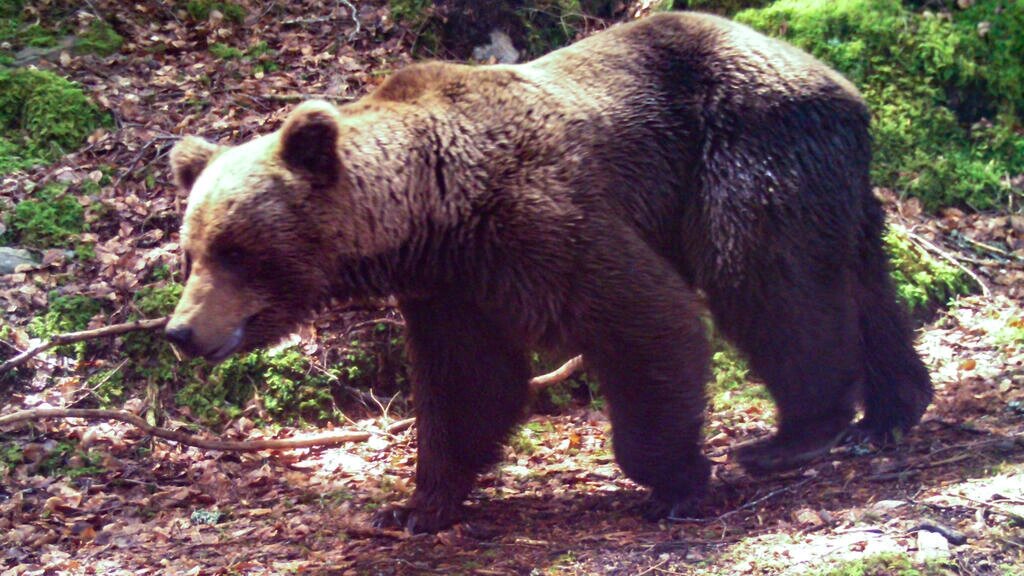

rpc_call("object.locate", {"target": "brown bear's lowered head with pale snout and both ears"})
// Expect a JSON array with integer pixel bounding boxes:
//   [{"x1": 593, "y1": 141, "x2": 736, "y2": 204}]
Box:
[{"x1": 166, "y1": 101, "x2": 341, "y2": 362}]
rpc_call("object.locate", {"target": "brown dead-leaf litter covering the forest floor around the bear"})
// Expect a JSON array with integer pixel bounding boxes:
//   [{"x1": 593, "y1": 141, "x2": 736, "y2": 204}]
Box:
[{"x1": 0, "y1": 0, "x2": 1024, "y2": 576}]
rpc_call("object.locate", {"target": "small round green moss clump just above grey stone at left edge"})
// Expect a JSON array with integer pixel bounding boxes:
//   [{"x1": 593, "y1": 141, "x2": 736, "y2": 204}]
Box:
[{"x1": 3, "y1": 184, "x2": 86, "y2": 248}]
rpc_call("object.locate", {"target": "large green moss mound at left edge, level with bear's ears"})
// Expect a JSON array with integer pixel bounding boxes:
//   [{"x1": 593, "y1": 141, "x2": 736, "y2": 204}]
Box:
[{"x1": 0, "y1": 69, "x2": 111, "y2": 174}]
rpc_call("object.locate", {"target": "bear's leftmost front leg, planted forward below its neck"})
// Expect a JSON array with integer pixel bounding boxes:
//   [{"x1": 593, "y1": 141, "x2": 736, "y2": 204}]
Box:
[{"x1": 374, "y1": 298, "x2": 529, "y2": 533}]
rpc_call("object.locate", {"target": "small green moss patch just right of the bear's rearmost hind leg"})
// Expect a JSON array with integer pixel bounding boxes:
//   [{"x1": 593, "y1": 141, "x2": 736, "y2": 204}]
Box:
[{"x1": 884, "y1": 224, "x2": 971, "y2": 318}]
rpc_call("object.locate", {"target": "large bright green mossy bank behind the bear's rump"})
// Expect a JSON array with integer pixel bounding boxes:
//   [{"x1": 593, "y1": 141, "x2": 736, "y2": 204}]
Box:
[{"x1": 737, "y1": 0, "x2": 1024, "y2": 209}]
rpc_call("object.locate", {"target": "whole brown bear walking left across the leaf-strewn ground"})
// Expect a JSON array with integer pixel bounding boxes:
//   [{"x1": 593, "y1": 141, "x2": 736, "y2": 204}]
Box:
[{"x1": 167, "y1": 13, "x2": 932, "y2": 531}]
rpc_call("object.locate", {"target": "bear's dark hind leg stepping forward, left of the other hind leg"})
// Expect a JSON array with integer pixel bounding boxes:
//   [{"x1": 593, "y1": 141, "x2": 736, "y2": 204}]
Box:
[{"x1": 709, "y1": 274, "x2": 862, "y2": 475}]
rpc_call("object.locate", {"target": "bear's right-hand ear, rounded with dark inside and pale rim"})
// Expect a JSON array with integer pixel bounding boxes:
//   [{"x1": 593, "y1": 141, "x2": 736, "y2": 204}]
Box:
[{"x1": 281, "y1": 100, "x2": 341, "y2": 187}]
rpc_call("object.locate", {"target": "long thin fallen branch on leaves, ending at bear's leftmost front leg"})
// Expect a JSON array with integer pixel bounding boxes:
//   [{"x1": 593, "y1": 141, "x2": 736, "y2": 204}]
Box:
[{"x1": 0, "y1": 408, "x2": 415, "y2": 452}]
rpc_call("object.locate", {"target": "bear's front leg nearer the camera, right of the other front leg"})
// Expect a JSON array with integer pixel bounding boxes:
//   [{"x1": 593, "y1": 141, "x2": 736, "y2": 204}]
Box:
[{"x1": 575, "y1": 234, "x2": 711, "y2": 520}]
